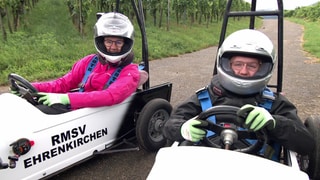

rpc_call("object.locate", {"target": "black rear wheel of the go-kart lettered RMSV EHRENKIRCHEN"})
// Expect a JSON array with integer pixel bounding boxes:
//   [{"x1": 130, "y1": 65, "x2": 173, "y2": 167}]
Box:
[{"x1": 136, "y1": 98, "x2": 172, "y2": 152}]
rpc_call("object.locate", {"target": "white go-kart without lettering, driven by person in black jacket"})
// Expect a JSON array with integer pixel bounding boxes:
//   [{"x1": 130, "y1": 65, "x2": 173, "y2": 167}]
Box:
[{"x1": 147, "y1": 106, "x2": 320, "y2": 180}]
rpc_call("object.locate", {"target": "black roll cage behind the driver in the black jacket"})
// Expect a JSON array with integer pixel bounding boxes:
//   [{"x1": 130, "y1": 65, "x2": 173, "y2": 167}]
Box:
[{"x1": 213, "y1": 0, "x2": 283, "y2": 92}]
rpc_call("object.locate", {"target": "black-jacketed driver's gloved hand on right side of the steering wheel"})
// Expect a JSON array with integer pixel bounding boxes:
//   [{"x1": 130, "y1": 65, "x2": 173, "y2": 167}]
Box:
[{"x1": 237, "y1": 104, "x2": 276, "y2": 131}]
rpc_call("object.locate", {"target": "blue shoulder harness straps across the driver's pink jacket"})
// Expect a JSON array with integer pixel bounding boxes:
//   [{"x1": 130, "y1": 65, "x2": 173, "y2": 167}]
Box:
[{"x1": 79, "y1": 55, "x2": 123, "y2": 92}]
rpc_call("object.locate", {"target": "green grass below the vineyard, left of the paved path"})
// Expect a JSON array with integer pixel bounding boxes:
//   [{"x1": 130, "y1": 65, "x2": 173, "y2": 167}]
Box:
[{"x1": 0, "y1": 0, "x2": 290, "y2": 85}]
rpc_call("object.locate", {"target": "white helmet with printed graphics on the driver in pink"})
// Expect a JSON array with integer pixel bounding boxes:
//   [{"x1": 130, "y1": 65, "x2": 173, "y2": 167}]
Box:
[{"x1": 94, "y1": 12, "x2": 134, "y2": 63}]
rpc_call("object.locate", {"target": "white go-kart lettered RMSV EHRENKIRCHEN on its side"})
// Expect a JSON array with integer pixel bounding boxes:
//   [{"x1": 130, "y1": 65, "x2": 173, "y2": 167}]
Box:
[{"x1": 0, "y1": 74, "x2": 172, "y2": 180}]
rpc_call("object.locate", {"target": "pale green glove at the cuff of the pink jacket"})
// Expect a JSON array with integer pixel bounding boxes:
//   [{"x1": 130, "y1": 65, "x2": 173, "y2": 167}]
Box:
[{"x1": 37, "y1": 92, "x2": 70, "y2": 106}]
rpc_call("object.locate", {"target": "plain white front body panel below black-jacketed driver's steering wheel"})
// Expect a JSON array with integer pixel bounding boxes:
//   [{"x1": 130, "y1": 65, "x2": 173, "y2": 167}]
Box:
[{"x1": 147, "y1": 146, "x2": 309, "y2": 180}]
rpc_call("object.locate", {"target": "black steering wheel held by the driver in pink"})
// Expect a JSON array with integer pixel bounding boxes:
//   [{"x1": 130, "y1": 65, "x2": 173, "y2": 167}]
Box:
[{"x1": 8, "y1": 73, "x2": 38, "y2": 105}]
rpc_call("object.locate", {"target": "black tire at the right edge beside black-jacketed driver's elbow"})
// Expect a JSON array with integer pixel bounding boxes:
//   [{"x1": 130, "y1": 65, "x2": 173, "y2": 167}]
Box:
[{"x1": 304, "y1": 115, "x2": 320, "y2": 180}]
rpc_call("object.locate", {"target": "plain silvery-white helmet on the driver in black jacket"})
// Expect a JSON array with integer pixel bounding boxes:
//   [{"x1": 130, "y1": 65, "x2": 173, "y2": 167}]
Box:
[{"x1": 217, "y1": 29, "x2": 277, "y2": 95}]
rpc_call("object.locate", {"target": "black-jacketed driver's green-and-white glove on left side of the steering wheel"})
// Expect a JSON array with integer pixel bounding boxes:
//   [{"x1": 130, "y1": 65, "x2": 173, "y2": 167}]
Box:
[{"x1": 181, "y1": 119, "x2": 206, "y2": 142}]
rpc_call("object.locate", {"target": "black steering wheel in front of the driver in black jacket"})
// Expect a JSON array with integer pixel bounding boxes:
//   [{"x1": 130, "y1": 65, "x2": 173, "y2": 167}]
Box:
[{"x1": 196, "y1": 105, "x2": 267, "y2": 154}]
